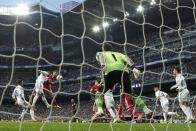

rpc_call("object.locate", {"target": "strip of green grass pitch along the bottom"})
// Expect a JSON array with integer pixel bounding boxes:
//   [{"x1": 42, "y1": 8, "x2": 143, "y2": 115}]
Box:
[{"x1": 0, "y1": 122, "x2": 196, "y2": 131}]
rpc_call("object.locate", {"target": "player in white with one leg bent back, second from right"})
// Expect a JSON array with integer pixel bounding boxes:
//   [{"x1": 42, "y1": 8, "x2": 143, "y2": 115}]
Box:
[{"x1": 154, "y1": 87, "x2": 178, "y2": 123}]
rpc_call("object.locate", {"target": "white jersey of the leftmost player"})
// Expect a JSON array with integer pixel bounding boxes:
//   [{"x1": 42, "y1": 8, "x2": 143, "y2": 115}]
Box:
[{"x1": 12, "y1": 85, "x2": 25, "y2": 105}]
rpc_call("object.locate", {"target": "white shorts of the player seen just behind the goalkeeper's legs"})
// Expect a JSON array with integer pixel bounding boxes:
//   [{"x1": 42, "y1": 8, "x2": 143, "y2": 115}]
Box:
[{"x1": 104, "y1": 91, "x2": 115, "y2": 109}]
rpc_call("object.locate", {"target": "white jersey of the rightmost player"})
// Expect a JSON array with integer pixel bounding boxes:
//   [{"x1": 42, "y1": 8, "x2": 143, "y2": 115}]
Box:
[{"x1": 171, "y1": 74, "x2": 187, "y2": 91}]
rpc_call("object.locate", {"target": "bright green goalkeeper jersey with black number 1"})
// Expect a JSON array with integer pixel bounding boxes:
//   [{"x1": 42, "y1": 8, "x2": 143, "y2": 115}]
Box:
[{"x1": 96, "y1": 51, "x2": 128, "y2": 75}]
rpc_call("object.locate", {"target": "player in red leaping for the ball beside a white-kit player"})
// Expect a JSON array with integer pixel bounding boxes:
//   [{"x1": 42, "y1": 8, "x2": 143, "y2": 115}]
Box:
[{"x1": 43, "y1": 70, "x2": 60, "y2": 108}]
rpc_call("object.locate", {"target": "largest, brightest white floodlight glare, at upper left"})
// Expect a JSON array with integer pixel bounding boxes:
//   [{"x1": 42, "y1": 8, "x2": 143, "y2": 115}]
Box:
[{"x1": 13, "y1": 5, "x2": 29, "y2": 15}]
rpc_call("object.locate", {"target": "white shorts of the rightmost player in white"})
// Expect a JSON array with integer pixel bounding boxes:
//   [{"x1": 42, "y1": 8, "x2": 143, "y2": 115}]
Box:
[{"x1": 178, "y1": 89, "x2": 190, "y2": 102}]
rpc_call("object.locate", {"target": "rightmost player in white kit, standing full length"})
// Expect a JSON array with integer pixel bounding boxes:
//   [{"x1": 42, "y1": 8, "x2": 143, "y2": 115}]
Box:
[{"x1": 170, "y1": 67, "x2": 193, "y2": 123}]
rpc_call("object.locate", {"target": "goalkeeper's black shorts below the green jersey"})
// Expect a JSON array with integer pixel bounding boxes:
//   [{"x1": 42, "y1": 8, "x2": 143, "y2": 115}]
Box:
[{"x1": 104, "y1": 70, "x2": 132, "y2": 94}]
